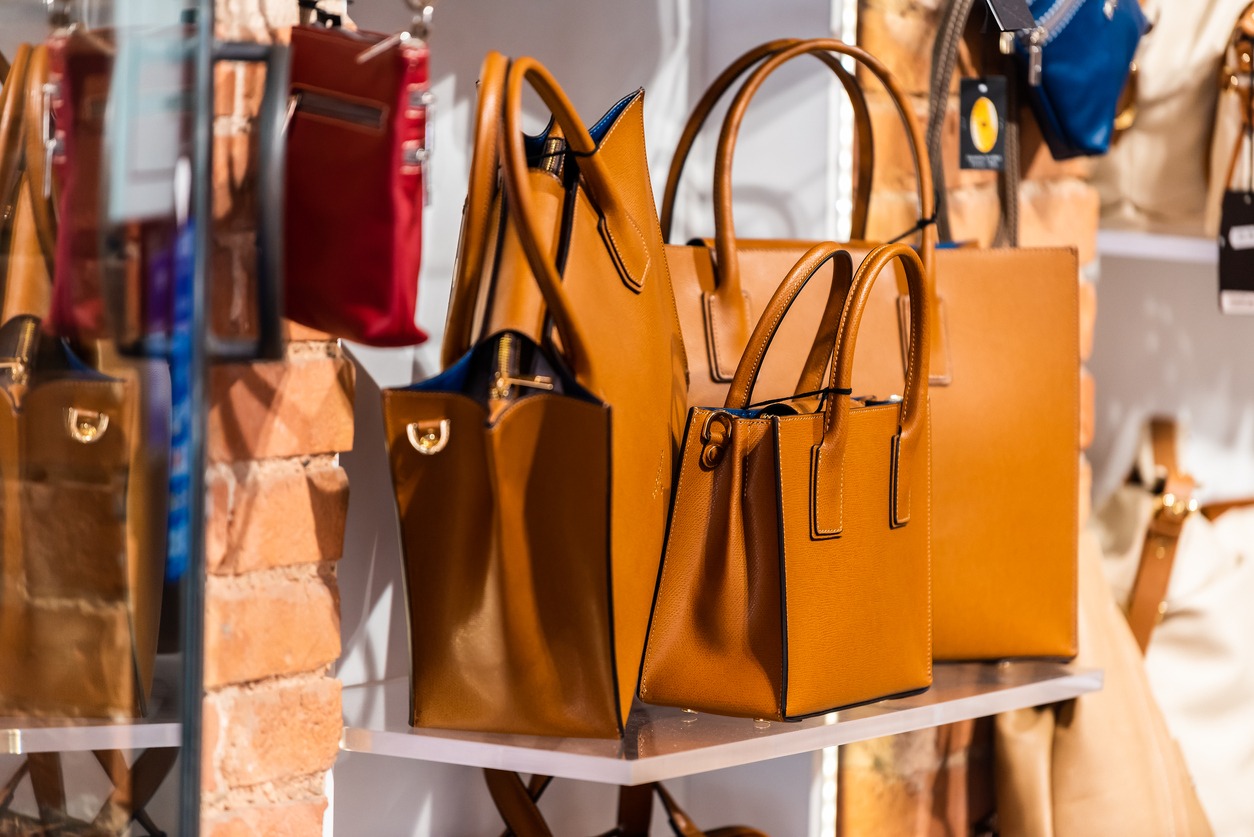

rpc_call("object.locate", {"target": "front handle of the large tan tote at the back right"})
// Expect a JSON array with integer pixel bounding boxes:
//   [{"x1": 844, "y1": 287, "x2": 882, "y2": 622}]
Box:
[{"x1": 714, "y1": 38, "x2": 935, "y2": 307}]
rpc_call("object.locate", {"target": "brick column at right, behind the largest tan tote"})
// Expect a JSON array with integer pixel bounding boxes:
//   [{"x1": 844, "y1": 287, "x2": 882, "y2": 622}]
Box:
[{"x1": 839, "y1": 0, "x2": 1100, "y2": 837}]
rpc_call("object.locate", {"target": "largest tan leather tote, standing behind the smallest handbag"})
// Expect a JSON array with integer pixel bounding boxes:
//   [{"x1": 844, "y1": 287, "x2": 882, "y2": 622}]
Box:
[{"x1": 663, "y1": 39, "x2": 1080, "y2": 660}]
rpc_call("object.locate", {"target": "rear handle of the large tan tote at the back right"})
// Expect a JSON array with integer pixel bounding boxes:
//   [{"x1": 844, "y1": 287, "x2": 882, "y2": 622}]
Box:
[{"x1": 661, "y1": 38, "x2": 875, "y2": 241}]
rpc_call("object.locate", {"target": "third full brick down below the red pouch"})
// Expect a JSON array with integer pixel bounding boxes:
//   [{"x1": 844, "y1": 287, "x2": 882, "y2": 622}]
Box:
[{"x1": 204, "y1": 567, "x2": 340, "y2": 688}]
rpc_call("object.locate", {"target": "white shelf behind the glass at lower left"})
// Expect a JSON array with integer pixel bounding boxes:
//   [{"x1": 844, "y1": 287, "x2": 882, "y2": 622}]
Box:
[{"x1": 0, "y1": 655, "x2": 182, "y2": 755}]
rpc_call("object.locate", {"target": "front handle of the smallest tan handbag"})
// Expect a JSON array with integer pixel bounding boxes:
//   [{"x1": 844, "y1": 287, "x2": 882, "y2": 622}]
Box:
[{"x1": 812, "y1": 243, "x2": 933, "y2": 537}]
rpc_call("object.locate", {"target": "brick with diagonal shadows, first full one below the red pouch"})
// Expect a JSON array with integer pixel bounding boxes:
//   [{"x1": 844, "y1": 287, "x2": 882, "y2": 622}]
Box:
[{"x1": 208, "y1": 356, "x2": 354, "y2": 462}]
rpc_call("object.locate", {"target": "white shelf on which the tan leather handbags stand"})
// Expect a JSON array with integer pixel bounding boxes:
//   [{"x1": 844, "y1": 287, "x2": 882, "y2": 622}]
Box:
[{"x1": 340, "y1": 663, "x2": 1102, "y2": 784}]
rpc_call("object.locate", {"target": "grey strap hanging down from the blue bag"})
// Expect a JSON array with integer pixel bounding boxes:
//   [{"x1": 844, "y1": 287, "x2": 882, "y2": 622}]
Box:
[{"x1": 927, "y1": 0, "x2": 1020, "y2": 247}]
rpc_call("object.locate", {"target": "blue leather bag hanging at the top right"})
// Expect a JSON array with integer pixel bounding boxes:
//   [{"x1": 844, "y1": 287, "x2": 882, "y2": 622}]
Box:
[{"x1": 1017, "y1": 0, "x2": 1149, "y2": 159}]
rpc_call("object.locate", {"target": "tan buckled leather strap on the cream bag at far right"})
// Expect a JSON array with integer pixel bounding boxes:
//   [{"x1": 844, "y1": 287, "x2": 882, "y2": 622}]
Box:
[{"x1": 1127, "y1": 417, "x2": 1198, "y2": 654}]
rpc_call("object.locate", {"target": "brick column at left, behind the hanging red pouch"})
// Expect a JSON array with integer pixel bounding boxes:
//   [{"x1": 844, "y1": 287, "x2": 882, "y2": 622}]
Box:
[{"x1": 201, "y1": 0, "x2": 354, "y2": 837}]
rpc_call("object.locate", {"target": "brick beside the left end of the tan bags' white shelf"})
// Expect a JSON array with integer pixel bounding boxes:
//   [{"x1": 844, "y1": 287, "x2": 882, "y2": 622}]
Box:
[{"x1": 207, "y1": 676, "x2": 344, "y2": 788}]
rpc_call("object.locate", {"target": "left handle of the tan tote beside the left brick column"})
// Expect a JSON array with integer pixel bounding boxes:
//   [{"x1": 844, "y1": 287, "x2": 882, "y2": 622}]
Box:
[{"x1": 440, "y1": 51, "x2": 509, "y2": 369}]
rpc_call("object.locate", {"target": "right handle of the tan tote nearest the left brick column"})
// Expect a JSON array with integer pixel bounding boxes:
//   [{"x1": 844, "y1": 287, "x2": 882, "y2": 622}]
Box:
[{"x1": 498, "y1": 58, "x2": 606, "y2": 392}]
